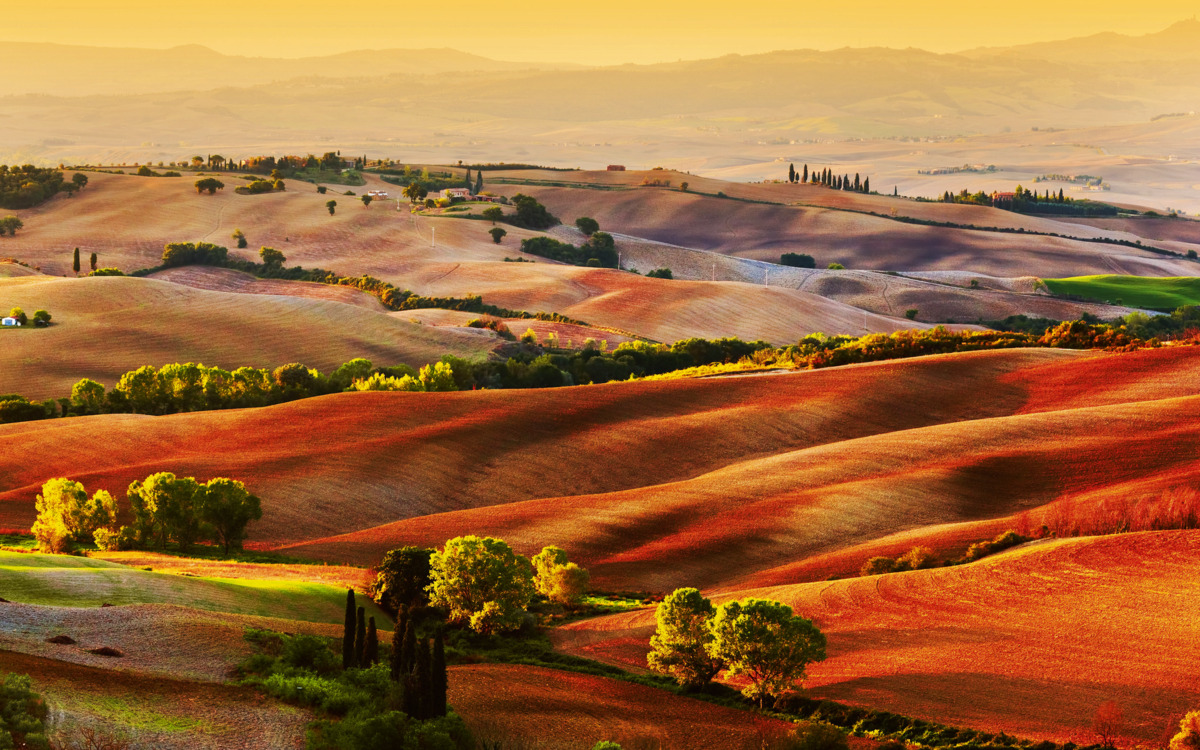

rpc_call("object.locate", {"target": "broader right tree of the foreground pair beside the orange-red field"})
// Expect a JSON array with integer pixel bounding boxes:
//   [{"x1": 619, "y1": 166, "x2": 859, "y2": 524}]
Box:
[{"x1": 708, "y1": 599, "x2": 826, "y2": 708}]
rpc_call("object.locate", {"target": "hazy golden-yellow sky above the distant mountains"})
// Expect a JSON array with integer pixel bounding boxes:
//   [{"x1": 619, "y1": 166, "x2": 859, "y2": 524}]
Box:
[{"x1": 0, "y1": 0, "x2": 1200, "y2": 65}]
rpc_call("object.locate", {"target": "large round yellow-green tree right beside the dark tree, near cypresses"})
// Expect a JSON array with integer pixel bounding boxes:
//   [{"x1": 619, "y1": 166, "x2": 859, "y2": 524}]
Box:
[{"x1": 428, "y1": 536, "x2": 533, "y2": 635}]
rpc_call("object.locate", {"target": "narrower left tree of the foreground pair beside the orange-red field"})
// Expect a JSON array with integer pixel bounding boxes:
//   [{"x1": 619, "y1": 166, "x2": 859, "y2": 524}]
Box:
[{"x1": 646, "y1": 588, "x2": 721, "y2": 688}]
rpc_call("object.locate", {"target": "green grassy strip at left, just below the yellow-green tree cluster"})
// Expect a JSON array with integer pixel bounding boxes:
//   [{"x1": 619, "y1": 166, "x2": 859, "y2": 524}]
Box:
[{"x1": 0, "y1": 552, "x2": 389, "y2": 623}]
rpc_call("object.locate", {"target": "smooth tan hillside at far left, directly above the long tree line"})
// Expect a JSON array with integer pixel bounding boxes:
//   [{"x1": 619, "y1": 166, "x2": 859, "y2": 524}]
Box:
[{"x1": 0, "y1": 276, "x2": 497, "y2": 398}]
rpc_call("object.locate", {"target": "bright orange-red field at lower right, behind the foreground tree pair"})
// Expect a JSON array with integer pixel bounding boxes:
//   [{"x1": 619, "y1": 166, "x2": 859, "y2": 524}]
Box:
[{"x1": 559, "y1": 532, "x2": 1200, "y2": 743}]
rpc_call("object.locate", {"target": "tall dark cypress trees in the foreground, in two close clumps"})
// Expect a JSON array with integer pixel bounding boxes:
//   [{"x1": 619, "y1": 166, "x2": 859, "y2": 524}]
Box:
[{"x1": 342, "y1": 589, "x2": 449, "y2": 720}]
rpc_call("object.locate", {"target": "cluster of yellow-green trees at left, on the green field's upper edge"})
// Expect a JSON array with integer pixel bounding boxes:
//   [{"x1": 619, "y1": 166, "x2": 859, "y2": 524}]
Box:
[{"x1": 32, "y1": 472, "x2": 263, "y2": 554}]
